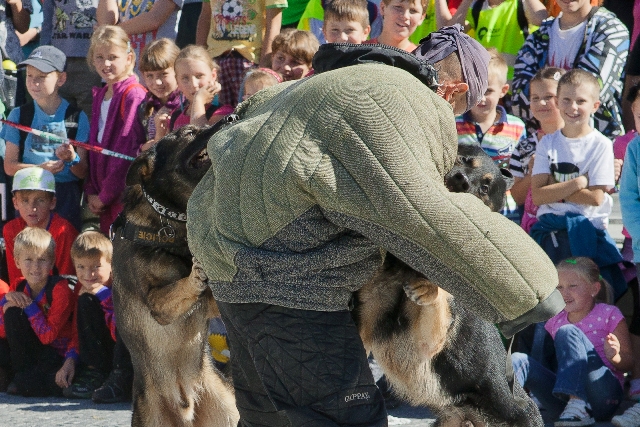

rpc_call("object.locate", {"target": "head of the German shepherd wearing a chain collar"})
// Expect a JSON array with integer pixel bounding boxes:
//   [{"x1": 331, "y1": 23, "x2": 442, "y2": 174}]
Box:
[{"x1": 126, "y1": 125, "x2": 218, "y2": 212}]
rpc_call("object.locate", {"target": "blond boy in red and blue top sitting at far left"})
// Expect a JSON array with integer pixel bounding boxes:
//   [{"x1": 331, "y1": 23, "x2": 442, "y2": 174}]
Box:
[{"x1": 0, "y1": 227, "x2": 75, "y2": 396}]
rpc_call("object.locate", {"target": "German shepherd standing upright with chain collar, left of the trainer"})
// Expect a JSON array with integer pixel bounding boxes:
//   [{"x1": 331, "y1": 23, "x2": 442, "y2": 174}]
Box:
[{"x1": 112, "y1": 126, "x2": 239, "y2": 427}]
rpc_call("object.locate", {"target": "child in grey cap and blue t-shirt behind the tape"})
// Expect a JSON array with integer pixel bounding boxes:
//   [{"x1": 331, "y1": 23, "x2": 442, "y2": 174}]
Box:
[{"x1": 0, "y1": 46, "x2": 89, "y2": 234}]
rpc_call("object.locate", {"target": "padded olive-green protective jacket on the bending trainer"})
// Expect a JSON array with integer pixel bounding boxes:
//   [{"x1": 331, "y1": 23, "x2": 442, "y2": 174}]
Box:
[{"x1": 187, "y1": 45, "x2": 564, "y2": 335}]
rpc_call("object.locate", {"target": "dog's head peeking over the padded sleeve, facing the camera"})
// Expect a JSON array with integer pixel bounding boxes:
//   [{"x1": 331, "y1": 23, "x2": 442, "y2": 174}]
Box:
[{"x1": 445, "y1": 144, "x2": 513, "y2": 212}]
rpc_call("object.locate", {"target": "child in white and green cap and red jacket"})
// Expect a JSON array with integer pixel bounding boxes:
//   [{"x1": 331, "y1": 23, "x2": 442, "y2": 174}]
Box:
[{"x1": 2, "y1": 166, "x2": 78, "y2": 285}]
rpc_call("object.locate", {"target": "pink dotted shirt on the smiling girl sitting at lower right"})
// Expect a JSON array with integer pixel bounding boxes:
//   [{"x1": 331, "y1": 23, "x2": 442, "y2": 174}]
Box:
[{"x1": 544, "y1": 303, "x2": 624, "y2": 386}]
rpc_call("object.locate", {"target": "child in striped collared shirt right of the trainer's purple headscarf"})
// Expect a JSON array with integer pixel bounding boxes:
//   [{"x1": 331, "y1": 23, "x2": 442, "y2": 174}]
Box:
[{"x1": 456, "y1": 48, "x2": 527, "y2": 223}]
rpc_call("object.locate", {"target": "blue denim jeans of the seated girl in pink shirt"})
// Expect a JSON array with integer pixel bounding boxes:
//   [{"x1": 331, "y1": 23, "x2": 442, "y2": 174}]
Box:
[{"x1": 512, "y1": 325, "x2": 623, "y2": 420}]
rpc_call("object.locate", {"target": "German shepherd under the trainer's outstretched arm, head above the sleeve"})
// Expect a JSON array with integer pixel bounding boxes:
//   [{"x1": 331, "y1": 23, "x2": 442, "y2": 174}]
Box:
[{"x1": 354, "y1": 145, "x2": 543, "y2": 427}]
